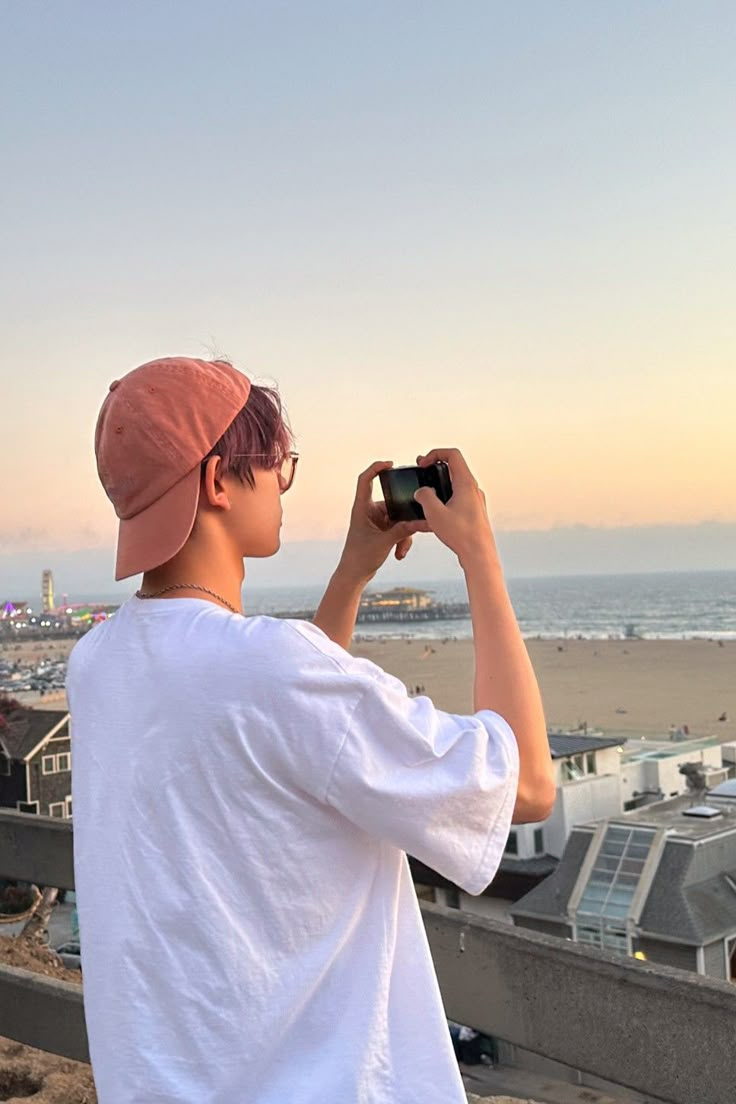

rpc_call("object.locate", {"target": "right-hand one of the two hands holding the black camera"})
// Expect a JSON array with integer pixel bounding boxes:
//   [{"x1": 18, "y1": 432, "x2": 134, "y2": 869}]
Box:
[{"x1": 414, "y1": 448, "x2": 498, "y2": 567}]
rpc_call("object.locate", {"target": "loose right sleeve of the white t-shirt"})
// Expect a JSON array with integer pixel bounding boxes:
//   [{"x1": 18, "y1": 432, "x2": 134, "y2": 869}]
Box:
[{"x1": 324, "y1": 660, "x2": 519, "y2": 894}]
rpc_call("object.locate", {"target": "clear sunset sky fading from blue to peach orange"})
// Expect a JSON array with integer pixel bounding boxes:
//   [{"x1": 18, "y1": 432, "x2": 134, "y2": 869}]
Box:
[{"x1": 0, "y1": 0, "x2": 736, "y2": 587}]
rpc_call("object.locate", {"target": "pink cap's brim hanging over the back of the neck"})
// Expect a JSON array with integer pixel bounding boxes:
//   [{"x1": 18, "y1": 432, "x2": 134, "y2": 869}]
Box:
[{"x1": 115, "y1": 464, "x2": 201, "y2": 580}]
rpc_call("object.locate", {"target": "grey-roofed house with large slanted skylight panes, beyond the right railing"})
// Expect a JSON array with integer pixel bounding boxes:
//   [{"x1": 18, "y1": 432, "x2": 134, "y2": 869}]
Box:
[{"x1": 510, "y1": 782, "x2": 736, "y2": 981}]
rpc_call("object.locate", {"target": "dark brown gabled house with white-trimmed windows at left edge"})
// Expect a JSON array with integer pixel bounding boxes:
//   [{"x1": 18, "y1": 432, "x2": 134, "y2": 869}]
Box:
[{"x1": 0, "y1": 707, "x2": 72, "y2": 817}]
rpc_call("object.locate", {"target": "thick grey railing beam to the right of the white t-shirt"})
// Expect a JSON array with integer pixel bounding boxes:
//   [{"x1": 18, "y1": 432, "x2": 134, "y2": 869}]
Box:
[{"x1": 422, "y1": 902, "x2": 736, "y2": 1104}]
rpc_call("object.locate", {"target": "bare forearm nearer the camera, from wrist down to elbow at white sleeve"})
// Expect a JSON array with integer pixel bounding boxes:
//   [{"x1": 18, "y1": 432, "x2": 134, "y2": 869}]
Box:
[{"x1": 462, "y1": 552, "x2": 555, "y2": 822}]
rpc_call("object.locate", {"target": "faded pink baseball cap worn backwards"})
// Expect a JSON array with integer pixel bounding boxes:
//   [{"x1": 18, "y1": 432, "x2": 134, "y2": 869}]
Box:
[{"x1": 95, "y1": 357, "x2": 250, "y2": 580}]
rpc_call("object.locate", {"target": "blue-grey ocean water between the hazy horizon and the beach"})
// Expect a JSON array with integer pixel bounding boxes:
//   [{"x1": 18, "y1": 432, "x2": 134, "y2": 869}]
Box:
[{"x1": 83, "y1": 571, "x2": 736, "y2": 640}]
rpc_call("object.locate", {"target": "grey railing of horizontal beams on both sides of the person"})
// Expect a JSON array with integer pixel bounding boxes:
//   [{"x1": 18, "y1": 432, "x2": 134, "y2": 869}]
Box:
[{"x1": 0, "y1": 810, "x2": 736, "y2": 1104}]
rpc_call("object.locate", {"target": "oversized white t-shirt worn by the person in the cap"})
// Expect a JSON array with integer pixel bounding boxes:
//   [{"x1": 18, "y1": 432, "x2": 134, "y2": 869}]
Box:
[{"x1": 67, "y1": 597, "x2": 519, "y2": 1104}]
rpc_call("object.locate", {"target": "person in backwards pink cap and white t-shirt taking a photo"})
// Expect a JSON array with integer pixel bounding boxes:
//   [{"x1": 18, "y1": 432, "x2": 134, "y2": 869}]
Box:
[{"x1": 66, "y1": 357, "x2": 555, "y2": 1104}]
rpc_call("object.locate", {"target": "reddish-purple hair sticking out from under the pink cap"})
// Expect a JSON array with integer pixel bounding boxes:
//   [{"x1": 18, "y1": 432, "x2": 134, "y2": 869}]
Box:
[{"x1": 202, "y1": 361, "x2": 294, "y2": 489}]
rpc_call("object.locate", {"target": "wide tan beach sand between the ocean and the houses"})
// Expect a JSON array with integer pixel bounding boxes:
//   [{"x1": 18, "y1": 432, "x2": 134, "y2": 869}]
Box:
[{"x1": 0, "y1": 630, "x2": 736, "y2": 740}]
